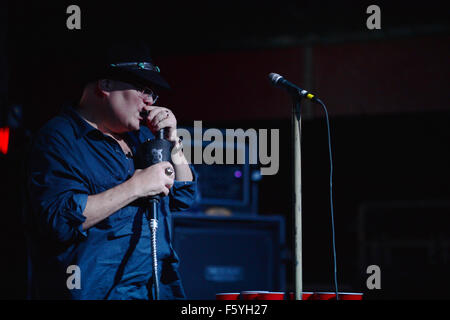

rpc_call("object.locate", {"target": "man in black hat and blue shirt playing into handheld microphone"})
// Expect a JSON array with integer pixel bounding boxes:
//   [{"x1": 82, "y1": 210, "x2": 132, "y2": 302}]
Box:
[{"x1": 28, "y1": 43, "x2": 196, "y2": 299}]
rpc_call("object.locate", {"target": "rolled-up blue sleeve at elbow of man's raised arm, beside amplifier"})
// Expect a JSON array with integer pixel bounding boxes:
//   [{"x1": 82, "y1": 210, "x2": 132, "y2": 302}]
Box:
[{"x1": 169, "y1": 165, "x2": 198, "y2": 211}]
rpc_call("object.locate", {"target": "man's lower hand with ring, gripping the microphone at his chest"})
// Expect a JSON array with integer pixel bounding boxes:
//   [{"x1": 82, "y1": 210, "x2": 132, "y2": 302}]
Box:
[{"x1": 129, "y1": 161, "x2": 175, "y2": 198}]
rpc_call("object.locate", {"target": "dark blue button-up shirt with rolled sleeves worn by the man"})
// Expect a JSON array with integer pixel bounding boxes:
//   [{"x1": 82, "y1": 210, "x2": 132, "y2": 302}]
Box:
[{"x1": 28, "y1": 108, "x2": 197, "y2": 299}]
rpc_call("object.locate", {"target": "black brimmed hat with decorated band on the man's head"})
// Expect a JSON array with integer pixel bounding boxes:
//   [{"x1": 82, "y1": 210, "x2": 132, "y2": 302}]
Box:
[{"x1": 81, "y1": 40, "x2": 170, "y2": 89}]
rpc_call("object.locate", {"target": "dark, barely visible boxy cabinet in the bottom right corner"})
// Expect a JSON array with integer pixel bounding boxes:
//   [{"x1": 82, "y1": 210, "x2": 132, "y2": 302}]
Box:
[{"x1": 358, "y1": 201, "x2": 450, "y2": 299}]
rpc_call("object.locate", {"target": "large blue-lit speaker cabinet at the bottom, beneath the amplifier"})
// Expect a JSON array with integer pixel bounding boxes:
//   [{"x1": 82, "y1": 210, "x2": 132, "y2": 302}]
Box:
[{"x1": 172, "y1": 214, "x2": 285, "y2": 300}]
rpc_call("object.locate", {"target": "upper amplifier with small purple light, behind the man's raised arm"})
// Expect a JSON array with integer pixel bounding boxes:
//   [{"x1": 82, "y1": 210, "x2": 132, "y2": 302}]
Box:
[{"x1": 177, "y1": 127, "x2": 262, "y2": 215}]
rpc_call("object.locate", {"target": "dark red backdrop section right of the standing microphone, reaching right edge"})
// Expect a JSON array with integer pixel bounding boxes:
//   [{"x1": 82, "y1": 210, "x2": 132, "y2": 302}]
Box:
[{"x1": 313, "y1": 37, "x2": 450, "y2": 115}]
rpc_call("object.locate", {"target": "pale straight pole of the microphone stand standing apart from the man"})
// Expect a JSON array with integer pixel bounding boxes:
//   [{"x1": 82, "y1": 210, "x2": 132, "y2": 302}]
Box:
[{"x1": 292, "y1": 95, "x2": 303, "y2": 300}]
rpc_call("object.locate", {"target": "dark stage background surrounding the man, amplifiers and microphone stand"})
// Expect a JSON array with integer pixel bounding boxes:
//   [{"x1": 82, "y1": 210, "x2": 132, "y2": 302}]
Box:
[{"x1": 0, "y1": 1, "x2": 450, "y2": 299}]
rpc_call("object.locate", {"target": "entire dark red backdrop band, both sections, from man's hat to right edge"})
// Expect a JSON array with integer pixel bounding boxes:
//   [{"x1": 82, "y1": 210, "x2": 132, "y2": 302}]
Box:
[{"x1": 156, "y1": 37, "x2": 450, "y2": 122}]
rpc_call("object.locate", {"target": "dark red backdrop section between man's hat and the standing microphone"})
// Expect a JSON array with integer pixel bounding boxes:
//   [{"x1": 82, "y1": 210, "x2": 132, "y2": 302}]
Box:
[{"x1": 157, "y1": 48, "x2": 303, "y2": 121}]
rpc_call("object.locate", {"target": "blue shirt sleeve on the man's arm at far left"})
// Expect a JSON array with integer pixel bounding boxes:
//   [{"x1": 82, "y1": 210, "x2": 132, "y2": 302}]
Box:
[{"x1": 28, "y1": 131, "x2": 89, "y2": 243}]
